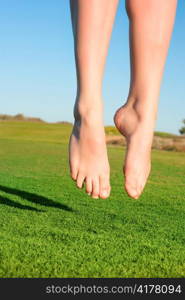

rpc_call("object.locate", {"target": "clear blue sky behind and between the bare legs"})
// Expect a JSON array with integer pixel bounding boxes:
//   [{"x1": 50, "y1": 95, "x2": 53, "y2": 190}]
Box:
[{"x1": 0, "y1": 0, "x2": 185, "y2": 133}]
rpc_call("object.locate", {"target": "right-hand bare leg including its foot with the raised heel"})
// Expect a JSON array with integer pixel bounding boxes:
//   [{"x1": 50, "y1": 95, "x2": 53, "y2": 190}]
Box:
[{"x1": 114, "y1": 0, "x2": 177, "y2": 198}]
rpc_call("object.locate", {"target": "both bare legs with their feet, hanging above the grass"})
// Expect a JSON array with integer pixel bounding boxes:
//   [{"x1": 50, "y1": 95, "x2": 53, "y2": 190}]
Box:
[{"x1": 69, "y1": 0, "x2": 177, "y2": 199}]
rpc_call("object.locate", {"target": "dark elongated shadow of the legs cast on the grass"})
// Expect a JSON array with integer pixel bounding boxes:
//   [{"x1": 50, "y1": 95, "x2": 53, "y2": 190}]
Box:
[{"x1": 0, "y1": 185, "x2": 73, "y2": 211}]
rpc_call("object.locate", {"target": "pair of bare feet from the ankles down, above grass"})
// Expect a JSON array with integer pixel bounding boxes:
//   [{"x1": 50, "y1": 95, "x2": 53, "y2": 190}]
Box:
[{"x1": 69, "y1": 99, "x2": 155, "y2": 199}]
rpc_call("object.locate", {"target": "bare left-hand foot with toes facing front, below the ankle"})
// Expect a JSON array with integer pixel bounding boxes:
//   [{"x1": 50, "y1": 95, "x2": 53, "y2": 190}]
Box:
[{"x1": 69, "y1": 102, "x2": 110, "y2": 199}]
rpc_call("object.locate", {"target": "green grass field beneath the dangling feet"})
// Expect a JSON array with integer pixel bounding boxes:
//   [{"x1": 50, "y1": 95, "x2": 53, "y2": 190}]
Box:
[{"x1": 0, "y1": 122, "x2": 185, "y2": 277}]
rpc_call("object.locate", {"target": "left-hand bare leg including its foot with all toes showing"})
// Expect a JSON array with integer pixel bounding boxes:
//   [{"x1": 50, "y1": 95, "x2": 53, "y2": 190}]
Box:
[{"x1": 69, "y1": 0, "x2": 118, "y2": 198}]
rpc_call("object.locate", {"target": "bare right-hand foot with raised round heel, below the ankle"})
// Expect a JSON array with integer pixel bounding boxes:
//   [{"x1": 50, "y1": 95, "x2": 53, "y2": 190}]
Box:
[{"x1": 114, "y1": 102, "x2": 154, "y2": 199}]
